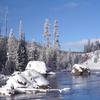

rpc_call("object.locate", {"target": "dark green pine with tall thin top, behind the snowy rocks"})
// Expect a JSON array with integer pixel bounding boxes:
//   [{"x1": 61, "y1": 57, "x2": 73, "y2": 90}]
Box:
[{"x1": 16, "y1": 20, "x2": 28, "y2": 71}]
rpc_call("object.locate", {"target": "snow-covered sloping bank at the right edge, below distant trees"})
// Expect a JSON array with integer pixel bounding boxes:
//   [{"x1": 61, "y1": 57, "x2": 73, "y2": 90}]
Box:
[{"x1": 82, "y1": 50, "x2": 100, "y2": 70}]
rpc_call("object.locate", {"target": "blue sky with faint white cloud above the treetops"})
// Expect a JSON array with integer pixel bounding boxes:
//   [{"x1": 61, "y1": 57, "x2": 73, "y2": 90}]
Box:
[{"x1": 0, "y1": 0, "x2": 100, "y2": 51}]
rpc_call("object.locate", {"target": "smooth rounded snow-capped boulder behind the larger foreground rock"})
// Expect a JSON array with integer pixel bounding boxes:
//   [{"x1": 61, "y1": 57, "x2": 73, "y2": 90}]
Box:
[{"x1": 26, "y1": 61, "x2": 47, "y2": 74}]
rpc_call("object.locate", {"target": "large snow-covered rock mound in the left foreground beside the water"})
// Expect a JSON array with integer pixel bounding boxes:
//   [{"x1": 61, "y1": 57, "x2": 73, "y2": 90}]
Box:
[{"x1": 0, "y1": 69, "x2": 49, "y2": 95}]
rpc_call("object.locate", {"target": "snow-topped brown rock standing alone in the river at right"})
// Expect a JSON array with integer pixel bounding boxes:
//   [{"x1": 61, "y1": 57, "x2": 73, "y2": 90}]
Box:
[{"x1": 72, "y1": 64, "x2": 90, "y2": 75}]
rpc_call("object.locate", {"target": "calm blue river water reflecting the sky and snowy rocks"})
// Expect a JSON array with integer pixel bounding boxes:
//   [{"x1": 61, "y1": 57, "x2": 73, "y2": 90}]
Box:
[{"x1": 0, "y1": 72, "x2": 100, "y2": 100}]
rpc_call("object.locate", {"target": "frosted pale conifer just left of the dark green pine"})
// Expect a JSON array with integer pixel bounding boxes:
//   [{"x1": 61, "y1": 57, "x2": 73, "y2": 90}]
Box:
[{"x1": 4, "y1": 29, "x2": 17, "y2": 75}]
